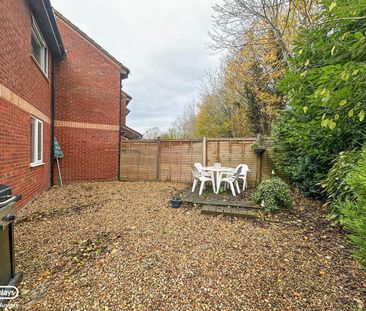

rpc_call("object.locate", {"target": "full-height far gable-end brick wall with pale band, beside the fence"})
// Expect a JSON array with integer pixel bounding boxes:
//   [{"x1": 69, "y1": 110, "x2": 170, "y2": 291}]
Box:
[{"x1": 55, "y1": 16, "x2": 125, "y2": 181}]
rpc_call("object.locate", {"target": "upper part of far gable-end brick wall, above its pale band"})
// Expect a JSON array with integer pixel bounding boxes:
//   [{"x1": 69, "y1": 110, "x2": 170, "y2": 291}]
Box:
[{"x1": 56, "y1": 17, "x2": 121, "y2": 125}]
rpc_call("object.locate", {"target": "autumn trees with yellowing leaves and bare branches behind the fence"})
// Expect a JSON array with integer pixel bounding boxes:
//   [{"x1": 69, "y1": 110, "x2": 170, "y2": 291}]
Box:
[{"x1": 198, "y1": 0, "x2": 317, "y2": 135}]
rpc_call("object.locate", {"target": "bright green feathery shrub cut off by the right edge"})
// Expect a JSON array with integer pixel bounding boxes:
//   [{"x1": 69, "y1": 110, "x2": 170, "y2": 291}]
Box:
[{"x1": 339, "y1": 147, "x2": 366, "y2": 267}]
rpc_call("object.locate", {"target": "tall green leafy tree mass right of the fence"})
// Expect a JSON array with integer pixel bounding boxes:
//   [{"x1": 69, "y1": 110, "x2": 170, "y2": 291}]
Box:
[{"x1": 274, "y1": 0, "x2": 366, "y2": 198}]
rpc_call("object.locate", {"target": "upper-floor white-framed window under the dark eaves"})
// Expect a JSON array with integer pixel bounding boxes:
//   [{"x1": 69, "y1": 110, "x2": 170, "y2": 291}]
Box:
[{"x1": 32, "y1": 16, "x2": 48, "y2": 76}]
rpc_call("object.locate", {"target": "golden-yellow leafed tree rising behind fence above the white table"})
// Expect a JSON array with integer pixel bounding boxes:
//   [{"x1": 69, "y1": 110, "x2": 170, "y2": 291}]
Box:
[{"x1": 225, "y1": 29, "x2": 286, "y2": 135}]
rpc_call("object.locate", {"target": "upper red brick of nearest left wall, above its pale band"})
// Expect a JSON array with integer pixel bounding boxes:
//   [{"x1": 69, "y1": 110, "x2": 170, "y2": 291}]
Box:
[{"x1": 0, "y1": 0, "x2": 51, "y2": 116}]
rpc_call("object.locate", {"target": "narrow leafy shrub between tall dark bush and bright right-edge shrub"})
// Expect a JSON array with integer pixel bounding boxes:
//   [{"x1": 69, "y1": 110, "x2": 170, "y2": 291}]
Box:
[{"x1": 321, "y1": 150, "x2": 360, "y2": 218}]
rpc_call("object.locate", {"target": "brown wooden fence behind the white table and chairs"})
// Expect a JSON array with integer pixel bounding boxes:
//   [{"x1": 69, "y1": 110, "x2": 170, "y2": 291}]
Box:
[{"x1": 121, "y1": 138, "x2": 272, "y2": 185}]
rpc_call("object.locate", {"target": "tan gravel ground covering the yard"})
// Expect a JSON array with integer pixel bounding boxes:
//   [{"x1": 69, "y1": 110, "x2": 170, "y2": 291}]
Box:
[{"x1": 10, "y1": 182, "x2": 366, "y2": 311}]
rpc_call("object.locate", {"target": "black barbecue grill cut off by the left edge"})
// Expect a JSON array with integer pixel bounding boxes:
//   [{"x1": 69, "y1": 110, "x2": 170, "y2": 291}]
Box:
[{"x1": 0, "y1": 185, "x2": 21, "y2": 305}]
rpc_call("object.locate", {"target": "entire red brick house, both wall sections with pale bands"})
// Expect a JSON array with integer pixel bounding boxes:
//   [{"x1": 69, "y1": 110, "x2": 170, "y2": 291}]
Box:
[{"x1": 0, "y1": 0, "x2": 133, "y2": 207}]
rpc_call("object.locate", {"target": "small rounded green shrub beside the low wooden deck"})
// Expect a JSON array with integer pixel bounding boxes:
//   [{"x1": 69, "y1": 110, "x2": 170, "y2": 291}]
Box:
[{"x1": 253, "y1": 177, "x2": 293, "y2": 212}]
